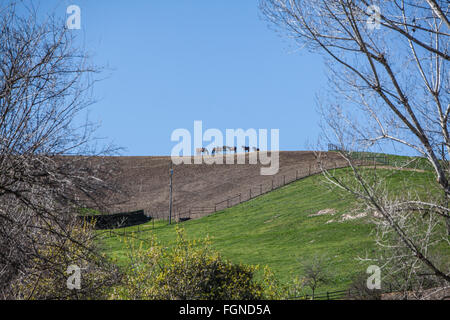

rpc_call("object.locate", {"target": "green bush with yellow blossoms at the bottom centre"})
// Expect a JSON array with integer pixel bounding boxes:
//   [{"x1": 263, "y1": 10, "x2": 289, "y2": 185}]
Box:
[{"x1": 111, "y1": 227, "x2": 282, "y2": 300}]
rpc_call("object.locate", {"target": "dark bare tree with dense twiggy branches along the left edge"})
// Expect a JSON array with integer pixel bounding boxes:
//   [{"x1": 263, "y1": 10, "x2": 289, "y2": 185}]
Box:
[{"x1": 0, "y1": 1, "x2": 119, "y2": 299}]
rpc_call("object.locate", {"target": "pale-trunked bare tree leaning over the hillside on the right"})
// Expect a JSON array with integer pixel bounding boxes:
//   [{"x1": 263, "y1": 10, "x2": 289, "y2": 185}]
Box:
[{"x1": 261, "y1": 0, "x2": 450, "y2": 290}]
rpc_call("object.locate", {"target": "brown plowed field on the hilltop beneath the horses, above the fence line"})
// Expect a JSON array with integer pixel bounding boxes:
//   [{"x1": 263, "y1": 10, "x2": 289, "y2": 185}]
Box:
[{"x1": 104, "y1": 151, "x2": 343, "y2": 218}]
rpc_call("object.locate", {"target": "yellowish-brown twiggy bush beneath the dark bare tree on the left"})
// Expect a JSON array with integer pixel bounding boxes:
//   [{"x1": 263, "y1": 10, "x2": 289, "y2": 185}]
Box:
[{"x1": 12, "y1": 220, "x2": 120, "y2": 300}]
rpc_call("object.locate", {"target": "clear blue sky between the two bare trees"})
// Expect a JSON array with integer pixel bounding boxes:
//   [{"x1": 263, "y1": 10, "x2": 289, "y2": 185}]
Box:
[{"x1": 41, "y1": 0, "x2": 326, "y2": 155}]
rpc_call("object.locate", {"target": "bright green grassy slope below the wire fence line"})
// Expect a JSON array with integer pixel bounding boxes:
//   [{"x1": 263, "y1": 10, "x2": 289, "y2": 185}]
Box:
[{"x1": 97, "y1": 169, "x2": 442, "y2": 292}]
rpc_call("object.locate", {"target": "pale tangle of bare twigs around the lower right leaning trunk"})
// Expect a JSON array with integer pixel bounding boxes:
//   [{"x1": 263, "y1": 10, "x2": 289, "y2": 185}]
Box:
[{"x1": 375, "y1": 195, "x2": 450, "y2": 299}]
